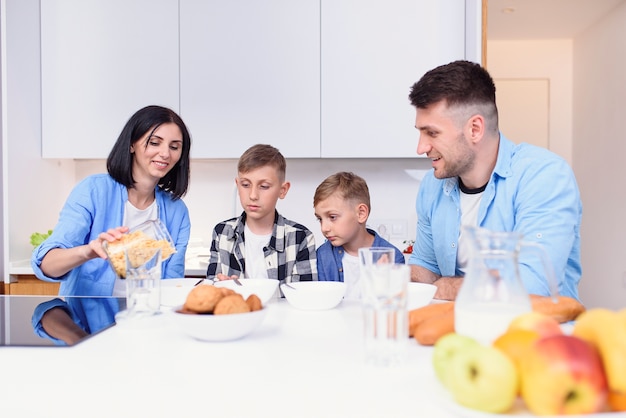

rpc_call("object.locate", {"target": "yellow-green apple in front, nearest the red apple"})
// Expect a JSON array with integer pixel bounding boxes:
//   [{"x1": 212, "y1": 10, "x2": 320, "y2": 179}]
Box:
[{"x1": 447, "y1": 345, "x2": 518, "y2": 413}]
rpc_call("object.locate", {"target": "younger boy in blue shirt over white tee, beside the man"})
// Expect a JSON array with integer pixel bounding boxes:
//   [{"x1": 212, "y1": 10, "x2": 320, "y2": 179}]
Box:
[{"x1": 313, "y1": 172, "x2": 404, "y2": 299}]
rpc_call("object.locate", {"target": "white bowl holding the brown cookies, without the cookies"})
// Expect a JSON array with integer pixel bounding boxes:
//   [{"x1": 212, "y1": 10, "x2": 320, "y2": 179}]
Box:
[{"x1": 168, "y1": 305, "x2": 267, "y2": 342}]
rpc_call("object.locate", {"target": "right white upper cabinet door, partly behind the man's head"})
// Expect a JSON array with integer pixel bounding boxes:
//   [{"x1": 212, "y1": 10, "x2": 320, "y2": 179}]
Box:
[{"x1": 321, "y1": 0, "x2": 465, "y2": 158}]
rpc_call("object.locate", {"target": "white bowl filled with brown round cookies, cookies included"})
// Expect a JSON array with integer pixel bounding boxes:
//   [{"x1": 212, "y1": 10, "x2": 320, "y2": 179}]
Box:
[{"x1": 169, "y1": 284, "x2": 267, "y2": 342}]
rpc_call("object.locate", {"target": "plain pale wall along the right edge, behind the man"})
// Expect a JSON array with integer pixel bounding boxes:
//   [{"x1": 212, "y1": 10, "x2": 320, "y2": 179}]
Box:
[{"x1": 573, "y1": 3, "x2": 626, "y2": 308}]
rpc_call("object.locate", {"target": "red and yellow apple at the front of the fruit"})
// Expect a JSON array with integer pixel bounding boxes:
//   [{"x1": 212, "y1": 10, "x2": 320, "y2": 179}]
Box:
[{"x1": 520, "y1": 335, "x2": 608, "y2": 415}]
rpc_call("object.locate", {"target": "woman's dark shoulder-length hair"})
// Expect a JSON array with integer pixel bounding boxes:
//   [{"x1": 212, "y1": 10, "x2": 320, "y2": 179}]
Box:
[{"x1": 107, "y1": 106, "x2": 191, "y2": 200}]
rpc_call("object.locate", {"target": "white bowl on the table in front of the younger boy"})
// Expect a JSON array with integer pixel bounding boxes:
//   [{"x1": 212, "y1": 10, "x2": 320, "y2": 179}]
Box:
[{"x1": 280, "y1": 281, "x2": 346, "y2": 311}]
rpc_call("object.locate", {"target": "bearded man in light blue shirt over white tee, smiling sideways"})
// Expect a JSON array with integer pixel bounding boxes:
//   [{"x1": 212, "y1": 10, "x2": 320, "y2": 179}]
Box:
[{"x1": 408, "y1": 61, "x2": 582, "y2": 300}]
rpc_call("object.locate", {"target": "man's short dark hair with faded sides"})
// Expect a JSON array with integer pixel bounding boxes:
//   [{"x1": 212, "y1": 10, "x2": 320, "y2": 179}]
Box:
[{"x1": 409, "y1": 61, "x2": 498, "y2": 131}]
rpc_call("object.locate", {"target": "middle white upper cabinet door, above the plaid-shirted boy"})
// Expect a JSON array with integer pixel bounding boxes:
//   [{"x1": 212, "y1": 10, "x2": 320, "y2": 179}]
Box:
[{"x1": 180, "y1": 0, "x2": 320, "y2": 158}]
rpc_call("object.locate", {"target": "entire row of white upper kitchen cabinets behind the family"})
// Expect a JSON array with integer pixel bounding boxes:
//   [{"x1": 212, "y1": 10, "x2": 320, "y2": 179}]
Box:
[{"x1": 40, "y1": 0, "x2": 480, "y2": 159}]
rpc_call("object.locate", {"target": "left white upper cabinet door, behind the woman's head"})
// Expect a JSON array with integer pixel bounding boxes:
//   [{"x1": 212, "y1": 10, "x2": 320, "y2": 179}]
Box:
[{"x1": 41, "y1": 0, "x2": 179, "y2": 158}]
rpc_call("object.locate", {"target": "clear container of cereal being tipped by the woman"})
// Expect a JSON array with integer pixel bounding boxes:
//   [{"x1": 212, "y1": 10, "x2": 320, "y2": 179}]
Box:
[{"x1": 102, "y1": 219, "x2": 176, "y2": 279}]
